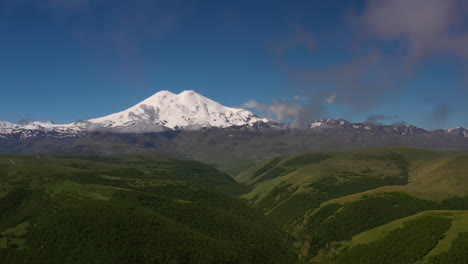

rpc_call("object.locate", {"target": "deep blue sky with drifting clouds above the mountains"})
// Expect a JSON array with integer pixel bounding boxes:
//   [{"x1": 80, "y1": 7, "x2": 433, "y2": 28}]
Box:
[{"x1": 0, "y1": 0, "x2": 468, "y2": 129}]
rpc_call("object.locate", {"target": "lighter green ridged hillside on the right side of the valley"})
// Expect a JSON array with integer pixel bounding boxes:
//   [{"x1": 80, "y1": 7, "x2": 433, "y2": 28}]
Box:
[{"x1": 236, "y1": 147, "x2": 468, "y2": 263}]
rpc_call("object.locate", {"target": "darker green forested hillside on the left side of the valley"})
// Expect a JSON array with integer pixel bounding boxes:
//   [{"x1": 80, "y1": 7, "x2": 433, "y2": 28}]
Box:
[{"x1": 0, "y1": 154, "x2": 297, "y2": 263}]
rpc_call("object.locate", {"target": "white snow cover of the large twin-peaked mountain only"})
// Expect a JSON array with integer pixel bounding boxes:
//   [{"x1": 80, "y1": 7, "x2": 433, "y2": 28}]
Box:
[{"x1": 88, "y1": 90, "x2": 268, "y2": 129}]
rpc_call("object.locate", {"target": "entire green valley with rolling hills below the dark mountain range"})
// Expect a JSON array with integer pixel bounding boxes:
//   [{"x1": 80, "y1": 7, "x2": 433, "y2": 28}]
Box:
[{"x1": 0, "y1": 147, "x2": 468, "y2": 264}]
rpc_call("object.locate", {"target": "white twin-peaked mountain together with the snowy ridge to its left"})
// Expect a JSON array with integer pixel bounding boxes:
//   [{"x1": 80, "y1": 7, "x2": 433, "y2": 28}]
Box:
[{"x1": 0, "y1": 90, "x2": 270, "y2": 134}]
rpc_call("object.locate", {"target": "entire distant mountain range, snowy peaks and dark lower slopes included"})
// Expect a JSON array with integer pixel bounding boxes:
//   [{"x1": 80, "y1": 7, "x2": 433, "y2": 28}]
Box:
[{"x1": 0, "y1": 91, "x2": 468, "y2": 167}]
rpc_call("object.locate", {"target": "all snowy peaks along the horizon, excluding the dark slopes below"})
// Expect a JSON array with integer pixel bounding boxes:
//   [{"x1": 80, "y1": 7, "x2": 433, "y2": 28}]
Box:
[{"x1": 0, "y1": 90, "x2": 468, "y2": 138}]
